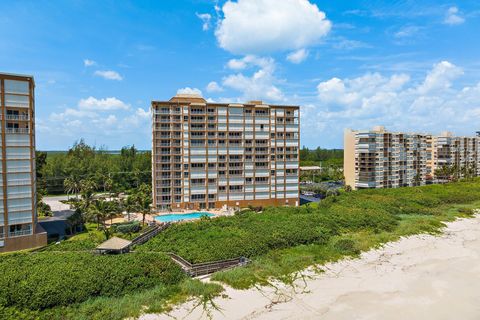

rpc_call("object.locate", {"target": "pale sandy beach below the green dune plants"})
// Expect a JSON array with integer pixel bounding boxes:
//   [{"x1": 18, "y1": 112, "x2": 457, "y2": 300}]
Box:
[{"x1": 142, "y1": 216, "x2": 480, "y2": 320}]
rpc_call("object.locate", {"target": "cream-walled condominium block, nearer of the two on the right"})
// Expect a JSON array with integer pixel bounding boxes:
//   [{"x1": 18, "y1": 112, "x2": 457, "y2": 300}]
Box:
[{"x1": 344, "y1": 127, "x2": 432, "y2": 189}]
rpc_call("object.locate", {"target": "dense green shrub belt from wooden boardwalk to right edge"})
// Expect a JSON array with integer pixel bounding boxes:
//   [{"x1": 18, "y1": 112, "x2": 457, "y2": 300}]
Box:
[{"x1": 137, "y1": 180, "x2": 480, "y2": 263}]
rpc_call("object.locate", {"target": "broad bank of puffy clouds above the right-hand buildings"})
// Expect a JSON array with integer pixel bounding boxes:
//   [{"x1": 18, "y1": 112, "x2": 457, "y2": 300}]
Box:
[{"x1": 301, "y1": 61, "x2": 480, "y2": 146}]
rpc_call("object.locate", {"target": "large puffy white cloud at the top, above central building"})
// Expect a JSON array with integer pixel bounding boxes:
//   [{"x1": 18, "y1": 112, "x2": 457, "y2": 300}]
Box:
[{"x1": 215, "y1": 0, "x2": 332, "y2": 54}]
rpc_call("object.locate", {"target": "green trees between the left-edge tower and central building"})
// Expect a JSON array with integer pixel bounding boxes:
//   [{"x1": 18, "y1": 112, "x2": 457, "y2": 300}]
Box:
[{"x1": 36, "y1": 139, "x2": 152, "y2": 195}]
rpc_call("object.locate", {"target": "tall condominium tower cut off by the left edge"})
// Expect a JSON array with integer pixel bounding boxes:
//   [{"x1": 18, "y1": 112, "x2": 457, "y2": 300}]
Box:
[{"x1": 0, "y1": 74, "x2": 47, "y2": 252}]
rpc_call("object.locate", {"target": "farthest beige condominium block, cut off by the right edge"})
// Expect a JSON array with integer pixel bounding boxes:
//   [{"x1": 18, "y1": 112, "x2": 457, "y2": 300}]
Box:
[{"x1": 432, "y1": 132, "x2": 480, "y2": 178}]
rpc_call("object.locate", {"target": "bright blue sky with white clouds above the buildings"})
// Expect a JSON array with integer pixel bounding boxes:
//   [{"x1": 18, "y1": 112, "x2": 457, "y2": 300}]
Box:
[{"x1": 0, "y1": 0, "x2": 480, "y2": 150}]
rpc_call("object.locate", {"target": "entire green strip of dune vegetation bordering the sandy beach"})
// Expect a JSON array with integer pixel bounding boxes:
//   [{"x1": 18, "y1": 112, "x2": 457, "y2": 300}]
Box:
[{"x1": 0, "y1": 179, "x2": 480, "y2": 320}]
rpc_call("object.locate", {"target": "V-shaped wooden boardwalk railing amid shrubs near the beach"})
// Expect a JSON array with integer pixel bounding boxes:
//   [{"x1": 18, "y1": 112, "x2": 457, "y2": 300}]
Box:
[{"x1": 168, "y1": 253, "x2": 250, "y2": 277}]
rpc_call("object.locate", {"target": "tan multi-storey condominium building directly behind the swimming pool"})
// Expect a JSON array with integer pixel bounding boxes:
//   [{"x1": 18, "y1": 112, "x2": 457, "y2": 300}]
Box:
[{"x1": 152, "y1": 95, "x2": 300, "y2": 210}]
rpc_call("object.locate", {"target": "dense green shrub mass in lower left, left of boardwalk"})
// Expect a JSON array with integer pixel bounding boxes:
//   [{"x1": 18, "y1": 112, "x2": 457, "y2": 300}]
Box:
[{"x1": 0, "y1": 252, "x2": 183, "y2": 310}]
